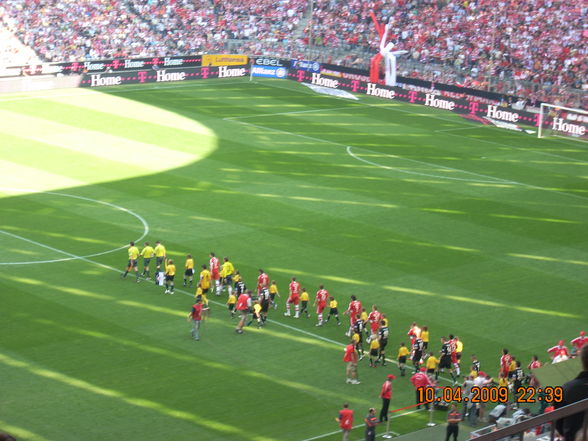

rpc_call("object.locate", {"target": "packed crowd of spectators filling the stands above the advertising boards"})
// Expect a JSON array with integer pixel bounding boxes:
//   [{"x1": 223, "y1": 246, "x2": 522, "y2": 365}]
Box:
[{"x1": 0, "y1": 0, "x2": 588, "y2": 107}]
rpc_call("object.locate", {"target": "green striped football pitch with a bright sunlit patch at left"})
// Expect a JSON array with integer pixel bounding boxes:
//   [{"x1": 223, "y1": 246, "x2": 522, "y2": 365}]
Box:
[{"x1": 0, "y1": 79, "x2": 588, "y2": 441}]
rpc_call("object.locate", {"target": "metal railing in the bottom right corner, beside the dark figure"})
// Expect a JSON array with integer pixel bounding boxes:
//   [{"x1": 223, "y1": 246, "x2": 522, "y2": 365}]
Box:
[{"x1": 475, "y1": 398, "x2": 588, "y2": 441}]
